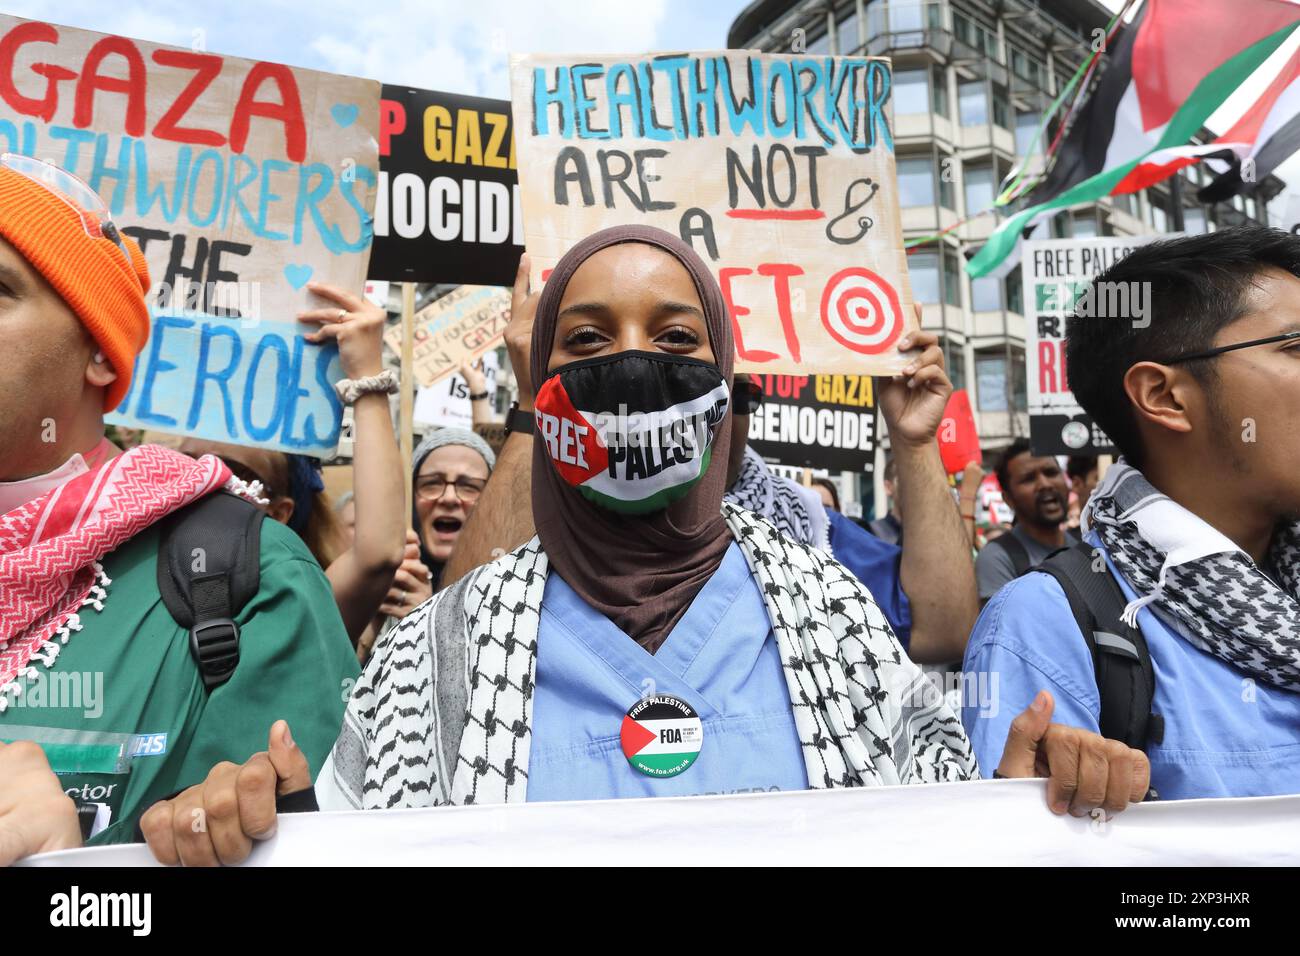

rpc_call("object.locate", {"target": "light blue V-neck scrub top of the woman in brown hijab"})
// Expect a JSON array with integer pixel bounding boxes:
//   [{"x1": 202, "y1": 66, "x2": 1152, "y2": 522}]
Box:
[{"x1": 528, "y1": 542, "x2": 807, "y2": 800}]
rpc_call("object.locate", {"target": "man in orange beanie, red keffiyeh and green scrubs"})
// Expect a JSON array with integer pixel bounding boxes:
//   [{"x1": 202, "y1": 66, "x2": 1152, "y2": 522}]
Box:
[{"x1": 0, "y1": 153, "x2": 358, "y2": 862}]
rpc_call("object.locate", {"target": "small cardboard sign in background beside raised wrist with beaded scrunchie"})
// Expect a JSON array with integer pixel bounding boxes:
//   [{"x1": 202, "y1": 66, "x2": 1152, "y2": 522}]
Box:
[{"x1": 384, "y1": 285, "x2": 511, "y2": 388}]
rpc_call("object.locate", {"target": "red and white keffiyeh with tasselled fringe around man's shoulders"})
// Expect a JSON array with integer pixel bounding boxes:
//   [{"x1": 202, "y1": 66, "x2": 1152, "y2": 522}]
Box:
[{"x1": 0, "y1": 445, "x2": 230, "y2": 711}]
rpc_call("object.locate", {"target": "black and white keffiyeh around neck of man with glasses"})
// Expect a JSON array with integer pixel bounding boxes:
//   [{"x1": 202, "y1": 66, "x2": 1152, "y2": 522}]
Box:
[{"x1": 1083, "y1": 459, "x2": 1300, "y2": 691}]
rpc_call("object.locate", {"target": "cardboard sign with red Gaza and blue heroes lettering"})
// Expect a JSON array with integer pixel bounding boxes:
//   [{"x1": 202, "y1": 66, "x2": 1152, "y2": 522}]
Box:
[{"x1": 0, "y1": 16, "x2": 380, "y2": 455}]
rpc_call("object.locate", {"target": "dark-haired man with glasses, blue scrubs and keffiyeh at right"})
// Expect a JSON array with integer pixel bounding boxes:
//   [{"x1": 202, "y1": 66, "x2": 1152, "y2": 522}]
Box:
[{"x1": 962, "y1": 226, "x2": 1300, "y2": 799}]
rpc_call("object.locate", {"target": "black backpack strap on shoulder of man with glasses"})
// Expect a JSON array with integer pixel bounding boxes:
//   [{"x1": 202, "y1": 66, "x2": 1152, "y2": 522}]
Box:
[{"x1": 1035, "y1": 541, "x2": 1165, "y2": 750}]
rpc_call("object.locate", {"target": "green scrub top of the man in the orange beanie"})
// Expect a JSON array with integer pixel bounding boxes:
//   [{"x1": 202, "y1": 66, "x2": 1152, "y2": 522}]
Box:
[{"x1": 0, "y1": 519, "x2": 359, "y2": 845}]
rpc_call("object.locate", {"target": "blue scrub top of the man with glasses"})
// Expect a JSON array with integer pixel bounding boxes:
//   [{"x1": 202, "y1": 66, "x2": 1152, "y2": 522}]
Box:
[{"x1": 962, "y1": 535, "x2": 1300, "y2": 800}]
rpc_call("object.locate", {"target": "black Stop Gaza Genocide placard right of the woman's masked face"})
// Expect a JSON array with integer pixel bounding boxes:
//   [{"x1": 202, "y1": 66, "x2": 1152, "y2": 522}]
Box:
[{"x1": 749, "y1": 375, "x2": 876, "y2": 472}]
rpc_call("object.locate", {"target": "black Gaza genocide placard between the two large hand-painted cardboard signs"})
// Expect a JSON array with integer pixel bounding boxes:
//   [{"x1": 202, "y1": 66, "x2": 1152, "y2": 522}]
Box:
[{"x1": 369, "y1": 86, "x2": 524, "y2": 285}]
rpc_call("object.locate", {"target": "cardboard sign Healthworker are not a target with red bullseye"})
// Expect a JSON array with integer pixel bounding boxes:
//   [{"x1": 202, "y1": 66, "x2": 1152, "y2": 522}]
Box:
[{"x1": 511, "y1": 51, "x2": 915, "y2": 375}]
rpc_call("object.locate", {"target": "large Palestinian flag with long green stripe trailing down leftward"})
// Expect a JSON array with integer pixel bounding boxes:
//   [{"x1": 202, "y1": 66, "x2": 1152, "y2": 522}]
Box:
[{"x1": 966, "y1": 0, "x2": 1300, "y2": 278}]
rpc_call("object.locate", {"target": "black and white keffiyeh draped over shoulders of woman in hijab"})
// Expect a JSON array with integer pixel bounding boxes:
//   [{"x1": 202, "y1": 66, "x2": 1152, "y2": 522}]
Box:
[{"x1": 316, "y1": 503, "x2": 979, "y2": 809}]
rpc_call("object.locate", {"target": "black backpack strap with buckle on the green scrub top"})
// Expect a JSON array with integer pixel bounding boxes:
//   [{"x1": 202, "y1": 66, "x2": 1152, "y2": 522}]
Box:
[{"x1": 157, "y1": 492, "x2": 265, "y2": 691}]
